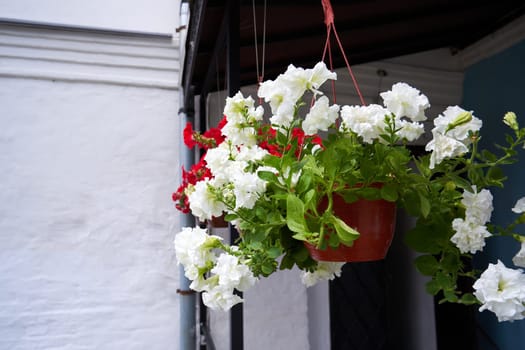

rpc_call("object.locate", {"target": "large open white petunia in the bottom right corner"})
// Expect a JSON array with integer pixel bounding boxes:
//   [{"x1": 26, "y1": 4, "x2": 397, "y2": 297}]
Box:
[{"x1": 473, "y1": 260, "x2": 525, "y2": 322}]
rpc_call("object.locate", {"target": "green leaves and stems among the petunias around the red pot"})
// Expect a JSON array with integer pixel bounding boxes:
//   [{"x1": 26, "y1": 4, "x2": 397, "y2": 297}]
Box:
[{"x1": 243, "y1": 109, "x2": 525, "y2": 305}]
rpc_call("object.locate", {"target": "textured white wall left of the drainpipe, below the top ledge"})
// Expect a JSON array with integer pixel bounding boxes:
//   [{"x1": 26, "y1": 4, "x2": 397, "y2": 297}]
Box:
[{"x1": 0, "y1": 24, "x2": 179, "y2": 350}]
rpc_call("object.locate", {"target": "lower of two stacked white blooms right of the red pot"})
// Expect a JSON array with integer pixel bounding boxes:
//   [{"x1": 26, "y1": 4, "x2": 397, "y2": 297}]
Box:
[{"x1": 450, "y1": 218, "x2": 491, "y2": 254}]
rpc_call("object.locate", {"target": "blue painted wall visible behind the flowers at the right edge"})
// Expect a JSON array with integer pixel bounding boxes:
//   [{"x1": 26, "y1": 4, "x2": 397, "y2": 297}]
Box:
[{"x1": 462, "y1": 41, "x2": 525, "y2": 350}]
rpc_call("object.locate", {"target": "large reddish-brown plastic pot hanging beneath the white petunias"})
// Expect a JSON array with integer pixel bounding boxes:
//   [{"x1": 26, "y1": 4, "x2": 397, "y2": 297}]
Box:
[{"x1": 305, "y1": 187, "x2": 396, "y2": 262}]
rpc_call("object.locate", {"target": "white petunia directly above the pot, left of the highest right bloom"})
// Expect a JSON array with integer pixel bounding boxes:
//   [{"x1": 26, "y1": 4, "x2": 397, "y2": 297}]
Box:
[{"x1": 340, "y1": 104, "x2": 390, "y2": 143}]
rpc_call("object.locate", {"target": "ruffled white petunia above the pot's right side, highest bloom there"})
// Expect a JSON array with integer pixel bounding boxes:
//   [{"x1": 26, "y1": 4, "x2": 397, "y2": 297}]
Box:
[{"x1": 380, "y1": 83, "x2": 430, "y2": 122}]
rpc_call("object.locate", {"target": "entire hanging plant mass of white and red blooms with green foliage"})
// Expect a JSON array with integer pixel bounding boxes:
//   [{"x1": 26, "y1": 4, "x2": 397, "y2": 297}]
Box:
[{"x1": 174, "y1": 62, "x2": 525, "y2": 320}]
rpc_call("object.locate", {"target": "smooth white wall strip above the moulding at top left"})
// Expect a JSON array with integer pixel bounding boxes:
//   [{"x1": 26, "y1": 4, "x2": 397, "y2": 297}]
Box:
[{"x1": 0, "y1": 0, "x2": 180, "y2": 34}]
